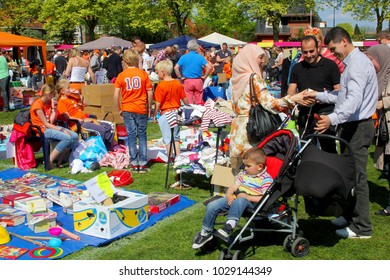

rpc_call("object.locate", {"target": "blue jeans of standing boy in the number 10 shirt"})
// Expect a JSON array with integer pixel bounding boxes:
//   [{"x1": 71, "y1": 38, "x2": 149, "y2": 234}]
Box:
[{"x1": 123, "y1": 112, "x2": 148, "y2": 166}]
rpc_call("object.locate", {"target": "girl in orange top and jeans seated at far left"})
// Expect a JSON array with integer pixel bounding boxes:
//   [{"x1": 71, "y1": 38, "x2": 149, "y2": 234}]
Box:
[{"x1": 30, "y1": 84, "x2": 79, "y2": 169}]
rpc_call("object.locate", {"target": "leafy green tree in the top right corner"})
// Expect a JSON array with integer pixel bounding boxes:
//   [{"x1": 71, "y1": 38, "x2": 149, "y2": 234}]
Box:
[{"x1": 343, "y1": 0, "x2": 390, "y2": 33}]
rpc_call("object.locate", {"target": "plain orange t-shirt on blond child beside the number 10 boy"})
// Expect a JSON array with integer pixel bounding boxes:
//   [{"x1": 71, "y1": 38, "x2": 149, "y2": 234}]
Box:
[{"x1": 154, "y1": 80, "x2": 186, "y2": 114}]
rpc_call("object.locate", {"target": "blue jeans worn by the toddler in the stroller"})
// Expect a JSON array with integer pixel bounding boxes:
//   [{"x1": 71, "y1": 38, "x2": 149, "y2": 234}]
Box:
[{"x1": 202, "y1": 197, "x2": 254, "y2": 233}]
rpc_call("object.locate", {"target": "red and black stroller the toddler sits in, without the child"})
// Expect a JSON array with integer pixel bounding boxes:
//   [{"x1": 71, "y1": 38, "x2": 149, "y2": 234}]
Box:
[{"x1": 194, "y1": 129, "x2": 310, "y2": 260}]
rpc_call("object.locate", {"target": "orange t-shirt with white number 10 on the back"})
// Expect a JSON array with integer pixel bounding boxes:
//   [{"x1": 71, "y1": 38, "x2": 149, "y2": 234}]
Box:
[{"x1": 115, "y1": 68, "x2": 153, "y2": 114}]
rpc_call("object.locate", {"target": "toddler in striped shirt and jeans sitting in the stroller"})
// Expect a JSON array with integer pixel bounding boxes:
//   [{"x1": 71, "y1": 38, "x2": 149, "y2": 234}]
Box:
[{"x1": 192, "y1": 147, "x2": 273, "y2": 249}]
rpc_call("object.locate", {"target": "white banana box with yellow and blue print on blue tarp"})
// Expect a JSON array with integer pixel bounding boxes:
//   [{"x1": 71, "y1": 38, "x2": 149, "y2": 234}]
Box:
[{"x1": 73, "y1": 191, "x2": 149, "y2": 239}]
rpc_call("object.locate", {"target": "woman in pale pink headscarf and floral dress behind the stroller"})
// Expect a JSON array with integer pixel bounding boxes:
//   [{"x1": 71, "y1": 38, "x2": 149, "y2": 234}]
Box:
[{"x1": 229, "y1": 44, "x2": 303, "y2": 175}]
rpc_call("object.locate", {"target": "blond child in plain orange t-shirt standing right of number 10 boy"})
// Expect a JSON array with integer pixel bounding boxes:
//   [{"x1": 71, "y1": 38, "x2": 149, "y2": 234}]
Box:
[{"x1": 153, "y1": 59, "x2": 188, "y2": 158}]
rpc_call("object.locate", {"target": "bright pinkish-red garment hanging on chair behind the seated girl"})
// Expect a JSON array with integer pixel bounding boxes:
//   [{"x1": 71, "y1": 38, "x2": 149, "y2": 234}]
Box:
[{"x1": 9, "y1": 130, "x2": 37, "y2": 170}]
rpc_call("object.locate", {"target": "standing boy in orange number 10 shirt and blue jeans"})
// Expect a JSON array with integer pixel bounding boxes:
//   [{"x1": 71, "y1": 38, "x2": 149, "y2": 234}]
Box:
[{"x1": 114, "y1": 49, "x2": 153, "y2": 173}]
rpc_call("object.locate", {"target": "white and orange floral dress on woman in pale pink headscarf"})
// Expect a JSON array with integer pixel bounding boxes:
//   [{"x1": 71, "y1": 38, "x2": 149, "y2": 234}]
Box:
[{"x1": 229, "y1": 75, "x2": 290, "y2": 158}]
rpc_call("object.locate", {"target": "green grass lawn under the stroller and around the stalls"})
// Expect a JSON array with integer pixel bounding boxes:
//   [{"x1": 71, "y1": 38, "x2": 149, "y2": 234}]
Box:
[{"x1": 0, "y1": 112, "x2": 390, "y2": 260}]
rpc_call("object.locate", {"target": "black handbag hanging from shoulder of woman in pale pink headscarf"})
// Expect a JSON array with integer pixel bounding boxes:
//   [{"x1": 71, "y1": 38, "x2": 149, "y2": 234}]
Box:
[{"x1": 246, "y1": 73, "x2": 282, "y2": 146}]
